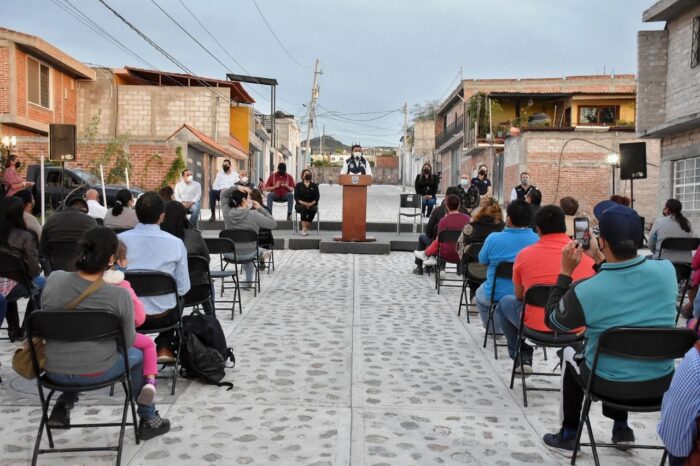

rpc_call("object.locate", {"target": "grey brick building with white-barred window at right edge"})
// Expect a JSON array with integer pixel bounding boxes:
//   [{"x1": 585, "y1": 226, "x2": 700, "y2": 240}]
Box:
[{"x1": 637, "y1": 0, "x2": 700, "y2": 232}]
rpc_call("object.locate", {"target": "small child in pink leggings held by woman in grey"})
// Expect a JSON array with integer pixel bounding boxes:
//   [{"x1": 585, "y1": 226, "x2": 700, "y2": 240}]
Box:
[{"x1": 102, "y1": 241, "x2": 158, "y2": 405}]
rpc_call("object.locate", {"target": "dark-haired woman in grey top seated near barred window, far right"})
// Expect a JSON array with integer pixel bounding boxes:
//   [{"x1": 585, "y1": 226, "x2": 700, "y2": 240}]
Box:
[{"x1": 648, "y1": 199, "x2": 693, "y2": 263}]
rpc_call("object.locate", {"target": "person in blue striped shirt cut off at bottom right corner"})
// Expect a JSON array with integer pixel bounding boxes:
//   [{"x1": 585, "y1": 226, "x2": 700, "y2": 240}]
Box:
[{"x1": 656, "y1": 343, "x2": 700, "y2": 466}]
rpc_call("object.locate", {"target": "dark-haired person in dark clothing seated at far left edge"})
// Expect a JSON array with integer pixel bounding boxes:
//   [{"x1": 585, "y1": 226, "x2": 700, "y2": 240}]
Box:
[{"x1": 0, "y1": 196, "x2": 45, "y2": 341}]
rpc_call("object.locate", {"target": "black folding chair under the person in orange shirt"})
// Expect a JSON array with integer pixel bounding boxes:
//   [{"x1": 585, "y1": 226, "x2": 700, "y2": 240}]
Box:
[{"x1": 510, "y1": 285, "x2": 584, "y2": 408}]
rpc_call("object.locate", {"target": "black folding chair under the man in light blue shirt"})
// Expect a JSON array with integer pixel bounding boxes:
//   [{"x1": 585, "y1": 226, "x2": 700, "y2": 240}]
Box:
[{"x1": 125, "y1": 271, "x2": 183, "y2": 395}]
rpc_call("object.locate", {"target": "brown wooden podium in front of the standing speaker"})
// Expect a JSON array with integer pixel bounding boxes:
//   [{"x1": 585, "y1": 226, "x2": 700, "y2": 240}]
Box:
[{"x1": 333, "y1": 174, "x2": 376, "y2": 242}]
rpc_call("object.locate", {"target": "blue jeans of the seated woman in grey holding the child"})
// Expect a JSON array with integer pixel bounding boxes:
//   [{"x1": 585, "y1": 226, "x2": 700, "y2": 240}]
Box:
[{"x1": 47, "y1": 348, "x2": 156, "y2": 419}]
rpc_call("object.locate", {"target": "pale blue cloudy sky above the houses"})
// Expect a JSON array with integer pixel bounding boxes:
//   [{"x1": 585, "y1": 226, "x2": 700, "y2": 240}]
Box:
[{"x1": 0, "y1": 0, "x2": 663, "y2": 146}]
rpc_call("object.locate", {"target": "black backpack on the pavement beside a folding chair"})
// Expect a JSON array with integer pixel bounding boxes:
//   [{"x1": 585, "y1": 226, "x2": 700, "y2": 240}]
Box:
[{"x1": 180, "y1": 311, "x2": 236, "y2": 390}]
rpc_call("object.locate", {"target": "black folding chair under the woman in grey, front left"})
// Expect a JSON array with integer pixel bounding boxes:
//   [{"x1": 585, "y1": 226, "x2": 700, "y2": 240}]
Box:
[{"x1": 27, "y1": 310, "x2": 139, "y2": 465}]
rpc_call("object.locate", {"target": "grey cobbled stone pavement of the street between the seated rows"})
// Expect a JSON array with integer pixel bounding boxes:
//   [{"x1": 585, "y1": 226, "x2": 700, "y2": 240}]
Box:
[{"x1": 0, "y1": 250, "x2": 660, "y2": 466}]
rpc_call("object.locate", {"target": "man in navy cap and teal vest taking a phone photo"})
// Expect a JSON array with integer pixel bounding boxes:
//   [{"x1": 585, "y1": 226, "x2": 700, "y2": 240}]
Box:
[{"x1": 543, "y1": 201, "x2": 678, "y2": 456}]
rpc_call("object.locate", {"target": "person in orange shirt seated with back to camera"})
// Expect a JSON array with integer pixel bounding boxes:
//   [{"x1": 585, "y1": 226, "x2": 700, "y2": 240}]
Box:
[{"x1": 494, "y1": 205, "x2": 595, "y2": 374}]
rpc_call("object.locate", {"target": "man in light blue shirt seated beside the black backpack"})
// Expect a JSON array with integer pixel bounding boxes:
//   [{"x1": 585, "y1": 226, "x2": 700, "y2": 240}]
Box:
[{"x1": 119, "y1": 192, "x2": 190, "y2": 364}]
